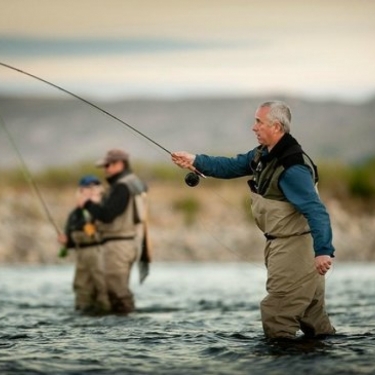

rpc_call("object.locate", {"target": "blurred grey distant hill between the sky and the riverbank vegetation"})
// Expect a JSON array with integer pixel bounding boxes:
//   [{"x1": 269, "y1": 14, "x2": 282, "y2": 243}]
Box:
[{"x1": 0, "y1": 97, "x2": 375, "y2": 168}]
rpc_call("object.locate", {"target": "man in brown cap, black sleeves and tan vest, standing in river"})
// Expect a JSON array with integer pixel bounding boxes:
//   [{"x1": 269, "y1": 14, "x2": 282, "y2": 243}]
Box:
[{"x1": 80, "y1": 149, "x2": 147, "y2": 314}]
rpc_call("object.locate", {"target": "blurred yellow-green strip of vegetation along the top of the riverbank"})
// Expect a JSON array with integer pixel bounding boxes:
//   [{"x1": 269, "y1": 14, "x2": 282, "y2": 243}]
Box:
[{"x1": 0, "y1": 156, "x2": 375, "y2": 204}]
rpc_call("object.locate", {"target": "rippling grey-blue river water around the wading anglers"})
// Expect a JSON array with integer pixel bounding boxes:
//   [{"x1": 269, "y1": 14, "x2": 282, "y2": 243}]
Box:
[{"x1": 0, "y1": 263, "x2": 375, "y2": 375}]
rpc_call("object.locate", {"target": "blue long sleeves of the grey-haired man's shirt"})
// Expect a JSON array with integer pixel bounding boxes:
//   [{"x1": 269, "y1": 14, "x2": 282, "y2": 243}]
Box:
[{"x1": 194, "y1": 150, "x2": 335, "y2": 256}]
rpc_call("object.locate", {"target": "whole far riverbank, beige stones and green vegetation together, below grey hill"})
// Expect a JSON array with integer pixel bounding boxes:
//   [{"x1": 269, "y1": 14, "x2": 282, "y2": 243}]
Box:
[{"x1": 0, "y1": 158, "x2": 375, "y2": 263}]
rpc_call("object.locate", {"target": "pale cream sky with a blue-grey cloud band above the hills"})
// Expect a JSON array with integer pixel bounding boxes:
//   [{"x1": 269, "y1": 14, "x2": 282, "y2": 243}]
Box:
[{"x1": 0, "y1": 0, "x2": 375, "y2": 101}]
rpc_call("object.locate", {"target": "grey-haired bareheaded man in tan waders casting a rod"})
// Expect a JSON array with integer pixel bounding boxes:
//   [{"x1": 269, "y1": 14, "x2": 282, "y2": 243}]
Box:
[{"x1": 172, "y1": 101, "x2": 335, "y2": 339}]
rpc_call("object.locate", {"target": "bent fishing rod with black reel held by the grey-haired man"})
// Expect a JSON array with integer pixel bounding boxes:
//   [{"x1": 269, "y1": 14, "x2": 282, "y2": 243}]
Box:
[{"x1": 0, "y1": 61, "x2": 206, "y2": 187}]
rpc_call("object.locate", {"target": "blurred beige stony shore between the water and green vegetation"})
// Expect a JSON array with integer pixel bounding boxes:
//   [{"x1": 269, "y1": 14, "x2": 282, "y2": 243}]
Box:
[{"x1": 0, "y1": 182, "x2": 375, "y2": 264}]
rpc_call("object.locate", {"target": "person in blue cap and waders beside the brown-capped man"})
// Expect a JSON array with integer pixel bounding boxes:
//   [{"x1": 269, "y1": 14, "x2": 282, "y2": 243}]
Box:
[{"x1": 58, "y1": 175, "x2": 110, "y2": 314}]
